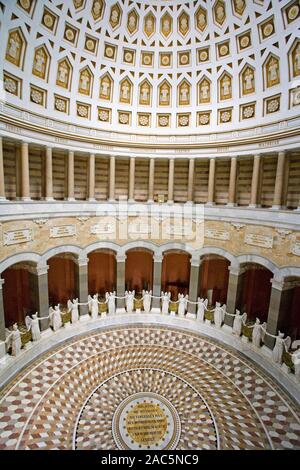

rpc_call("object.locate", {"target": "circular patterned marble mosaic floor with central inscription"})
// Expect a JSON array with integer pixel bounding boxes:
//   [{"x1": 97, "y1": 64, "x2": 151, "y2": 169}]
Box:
[{"x1": 0, "y1": 325, "x2": 300, "y2": 450}]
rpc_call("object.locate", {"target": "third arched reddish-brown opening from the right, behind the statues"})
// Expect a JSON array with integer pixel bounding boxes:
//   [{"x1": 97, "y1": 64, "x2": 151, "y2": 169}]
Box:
[{"x1": 199, "y1": 255, "x2": 230, "y2": 305}]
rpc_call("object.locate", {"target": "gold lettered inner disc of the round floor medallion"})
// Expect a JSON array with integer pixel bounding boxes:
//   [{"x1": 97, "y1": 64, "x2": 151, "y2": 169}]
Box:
[{"x1": 125, "y1": 402, "x2": 168, "y2": 446}]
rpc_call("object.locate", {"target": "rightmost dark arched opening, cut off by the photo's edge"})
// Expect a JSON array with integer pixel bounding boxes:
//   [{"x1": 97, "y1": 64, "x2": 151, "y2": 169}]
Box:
[{"x1": 280, "y1": 277, "x2": 300, "y2": 340}]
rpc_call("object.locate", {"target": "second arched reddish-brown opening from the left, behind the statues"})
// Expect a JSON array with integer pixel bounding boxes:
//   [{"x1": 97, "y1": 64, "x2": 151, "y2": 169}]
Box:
[{"x1": 47, "y1": 253, "x2": 78, "y2": 305}]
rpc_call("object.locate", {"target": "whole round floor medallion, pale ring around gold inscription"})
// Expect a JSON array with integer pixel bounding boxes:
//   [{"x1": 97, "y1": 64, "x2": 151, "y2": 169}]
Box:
[{"x1": 112, "y1": 392, "x2": 181, "y2": 450}]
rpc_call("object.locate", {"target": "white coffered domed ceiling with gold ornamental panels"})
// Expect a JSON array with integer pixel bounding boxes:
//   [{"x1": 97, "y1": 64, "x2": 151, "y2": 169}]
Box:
[{"x1": 0, "y1": 0, "x2": 300, "y2": 134}]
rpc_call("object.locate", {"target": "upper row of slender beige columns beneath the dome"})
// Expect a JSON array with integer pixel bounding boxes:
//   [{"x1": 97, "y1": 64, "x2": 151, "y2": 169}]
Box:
[{"x1": 0, "y1": 137, "x2": 300, "y2": 209}]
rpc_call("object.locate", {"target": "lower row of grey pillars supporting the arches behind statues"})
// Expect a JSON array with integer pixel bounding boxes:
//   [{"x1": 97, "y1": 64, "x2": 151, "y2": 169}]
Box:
[{"x1": 0, "y1": 248, "x2": 300, "y2": 346}]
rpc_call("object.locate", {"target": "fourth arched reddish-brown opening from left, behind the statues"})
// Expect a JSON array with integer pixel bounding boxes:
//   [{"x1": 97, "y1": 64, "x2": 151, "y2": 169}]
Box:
[{"x1": 125, "y1": 248, "x2": 153, "y2": 293}]
